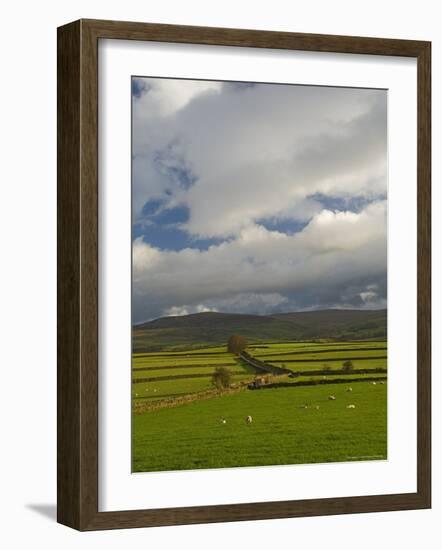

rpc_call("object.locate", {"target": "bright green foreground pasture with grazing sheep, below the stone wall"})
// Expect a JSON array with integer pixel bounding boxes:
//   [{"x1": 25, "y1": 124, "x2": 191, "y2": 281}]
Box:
[{"x1": 132, "y1": 382, "x2": 387, "y2": 472}]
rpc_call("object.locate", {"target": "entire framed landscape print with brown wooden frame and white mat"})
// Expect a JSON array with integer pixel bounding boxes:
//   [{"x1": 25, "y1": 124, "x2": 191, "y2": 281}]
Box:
[{"x1": 58, "y1": 20, "x2": 431, "y2": 530}]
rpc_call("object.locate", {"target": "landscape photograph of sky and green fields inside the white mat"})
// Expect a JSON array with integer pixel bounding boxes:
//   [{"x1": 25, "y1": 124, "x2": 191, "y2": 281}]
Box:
[{"x1": 131, "y1": 76, "x2": 388, "y2": 472}]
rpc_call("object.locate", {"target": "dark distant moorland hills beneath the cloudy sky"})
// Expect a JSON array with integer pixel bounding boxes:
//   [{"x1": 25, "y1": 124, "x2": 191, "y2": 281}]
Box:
[{"x1": 133, "y1": 309, "x2": 387, "y2": 352}]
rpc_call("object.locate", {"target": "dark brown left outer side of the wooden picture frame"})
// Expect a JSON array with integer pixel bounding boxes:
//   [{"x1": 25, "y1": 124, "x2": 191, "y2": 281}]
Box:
[{"x1": 57, "y1": 22, "x2": 81, "y2": 527}]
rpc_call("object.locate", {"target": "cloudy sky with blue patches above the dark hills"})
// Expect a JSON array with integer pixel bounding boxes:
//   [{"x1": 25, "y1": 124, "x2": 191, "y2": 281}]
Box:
[{"x1": 132, "y1": 78, "x2": 387, "y2": 323}]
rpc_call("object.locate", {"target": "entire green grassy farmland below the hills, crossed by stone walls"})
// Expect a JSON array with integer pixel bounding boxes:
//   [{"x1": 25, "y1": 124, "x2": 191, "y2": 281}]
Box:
[{"x1": 132, "y1": 340, "x2": 387, "y2": 472}]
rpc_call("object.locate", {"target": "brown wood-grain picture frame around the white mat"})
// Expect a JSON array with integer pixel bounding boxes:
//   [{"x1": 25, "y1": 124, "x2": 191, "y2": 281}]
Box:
[{"x1": 57, "y1": 20, "x2": 431, "y2": 531}]
